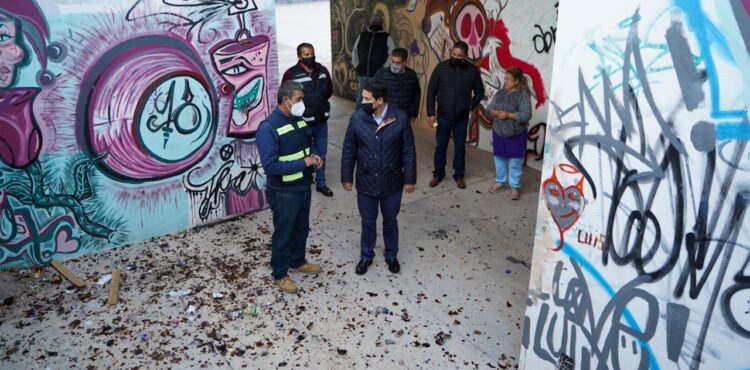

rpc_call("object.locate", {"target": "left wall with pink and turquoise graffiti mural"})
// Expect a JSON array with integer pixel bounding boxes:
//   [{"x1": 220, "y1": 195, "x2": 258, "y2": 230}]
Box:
[{"x1": 0, "y1": 0, "x2": 278, "y2": 268}]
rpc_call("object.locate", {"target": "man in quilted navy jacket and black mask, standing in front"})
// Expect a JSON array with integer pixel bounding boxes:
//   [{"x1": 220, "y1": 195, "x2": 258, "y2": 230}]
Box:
[{"x1": 341, "y1": 80, "x2": 417, "y2": 275}]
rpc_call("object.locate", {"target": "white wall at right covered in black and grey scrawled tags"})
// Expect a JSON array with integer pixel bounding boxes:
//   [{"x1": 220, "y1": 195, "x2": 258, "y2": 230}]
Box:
[{"x1": 521, "y1": 0, "x2": 750, "y2": 370}]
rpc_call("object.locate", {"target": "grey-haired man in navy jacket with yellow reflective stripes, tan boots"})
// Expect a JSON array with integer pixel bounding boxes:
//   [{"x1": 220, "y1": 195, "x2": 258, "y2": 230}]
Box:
[{"x1": 255, "y1": 81, "x2": 323, "y2": 293}]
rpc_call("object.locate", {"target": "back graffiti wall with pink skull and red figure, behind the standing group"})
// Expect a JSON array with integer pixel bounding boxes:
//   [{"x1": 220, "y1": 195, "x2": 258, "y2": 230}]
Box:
[{"x1": 331, "y1": 0, "x2": 558, "y2": 168}]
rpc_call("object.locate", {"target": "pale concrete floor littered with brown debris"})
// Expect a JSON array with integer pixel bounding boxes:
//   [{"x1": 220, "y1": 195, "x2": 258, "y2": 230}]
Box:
[{"x1": 0, "y1": 98, "x2": 539, "y2": 369}]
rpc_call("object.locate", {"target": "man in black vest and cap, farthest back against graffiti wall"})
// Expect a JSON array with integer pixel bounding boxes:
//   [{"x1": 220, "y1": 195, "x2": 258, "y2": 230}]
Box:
[{"x1": 352, "y1": 14, "x2": 395, "y2": 109}]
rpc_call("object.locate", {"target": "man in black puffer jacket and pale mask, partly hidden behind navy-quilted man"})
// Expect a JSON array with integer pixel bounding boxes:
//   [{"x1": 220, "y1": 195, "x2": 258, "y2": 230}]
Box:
[{"x1": 375, "y1": 48, "x2": 422, "y2": 119}]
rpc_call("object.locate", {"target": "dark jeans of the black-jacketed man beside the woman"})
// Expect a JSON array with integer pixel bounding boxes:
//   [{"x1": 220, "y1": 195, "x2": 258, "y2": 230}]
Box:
[{"x1": 432, "y1": 117, "x2": 469, "y2": 179}]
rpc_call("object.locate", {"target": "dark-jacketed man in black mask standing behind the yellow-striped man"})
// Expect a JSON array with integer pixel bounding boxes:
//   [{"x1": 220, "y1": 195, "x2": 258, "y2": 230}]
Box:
[{"x1": 281, "y1": 42, "x2": 333, "y2": 197}]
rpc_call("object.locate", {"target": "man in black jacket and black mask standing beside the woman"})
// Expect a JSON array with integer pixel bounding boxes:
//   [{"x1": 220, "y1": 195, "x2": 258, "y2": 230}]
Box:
[{"x1": 427, "y1": 41, "x2": 484, "y2": 189}]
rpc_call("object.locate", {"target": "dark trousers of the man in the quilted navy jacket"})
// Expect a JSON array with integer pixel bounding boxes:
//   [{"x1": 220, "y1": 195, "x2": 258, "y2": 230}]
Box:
[{"x1": 357, "y1": 191, "x2": 403, "y2": 261}]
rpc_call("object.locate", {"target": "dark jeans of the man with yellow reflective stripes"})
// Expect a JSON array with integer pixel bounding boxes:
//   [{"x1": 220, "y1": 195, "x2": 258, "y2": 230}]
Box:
[{"x1": 266, "y1": 189, "x2": 311, "y2": 279}]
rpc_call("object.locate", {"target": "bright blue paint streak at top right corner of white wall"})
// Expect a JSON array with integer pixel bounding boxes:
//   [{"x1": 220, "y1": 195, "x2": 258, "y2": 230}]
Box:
[{"x1": 673, "y1": 0, "x2": 747, "y2": 118}]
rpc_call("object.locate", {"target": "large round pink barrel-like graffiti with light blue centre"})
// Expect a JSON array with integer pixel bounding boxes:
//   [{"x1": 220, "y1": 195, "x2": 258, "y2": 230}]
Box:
[{"x1": 77, "y1": 36, "x2": 217, "y2": 182}]
